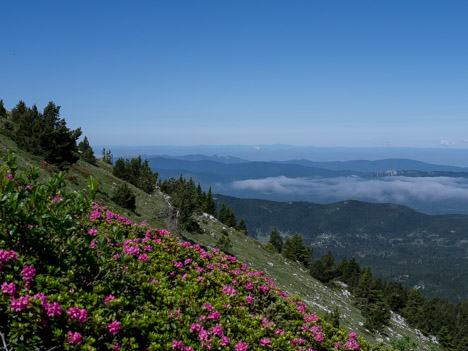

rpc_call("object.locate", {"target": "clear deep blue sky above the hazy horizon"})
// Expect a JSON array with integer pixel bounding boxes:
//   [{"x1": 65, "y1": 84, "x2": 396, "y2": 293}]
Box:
[{"x1": 0, "y1": 0, "x2": 468, "y2": 148}]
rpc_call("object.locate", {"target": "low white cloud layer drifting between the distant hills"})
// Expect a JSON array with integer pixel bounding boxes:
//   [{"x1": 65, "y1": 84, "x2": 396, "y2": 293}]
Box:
[{"x1": 231, "y1": 176, "x2": 468, "y2": 203}]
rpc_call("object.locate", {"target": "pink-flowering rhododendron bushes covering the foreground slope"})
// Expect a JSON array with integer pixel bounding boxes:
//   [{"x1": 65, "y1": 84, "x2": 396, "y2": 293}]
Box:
[{"x1": 0, "y1": 161, "x2": 390, "y2": 351}]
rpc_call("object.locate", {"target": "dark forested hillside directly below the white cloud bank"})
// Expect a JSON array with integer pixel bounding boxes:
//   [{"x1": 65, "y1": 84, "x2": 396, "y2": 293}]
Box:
[{"x1": 216, "y1": 195, "x2": 468, "y2": 303}]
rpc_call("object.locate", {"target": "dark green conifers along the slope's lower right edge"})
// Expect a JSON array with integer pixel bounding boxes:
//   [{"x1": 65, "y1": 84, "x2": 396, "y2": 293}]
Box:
[{"x1": 268, "y1": 229, "x2": 468, "y2": 351}]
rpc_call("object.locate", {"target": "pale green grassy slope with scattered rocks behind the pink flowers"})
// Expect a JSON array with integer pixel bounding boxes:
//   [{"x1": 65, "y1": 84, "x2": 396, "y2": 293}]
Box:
[{"x1": 0, "y1": 135, "x2": 438, "y2": 350}]
